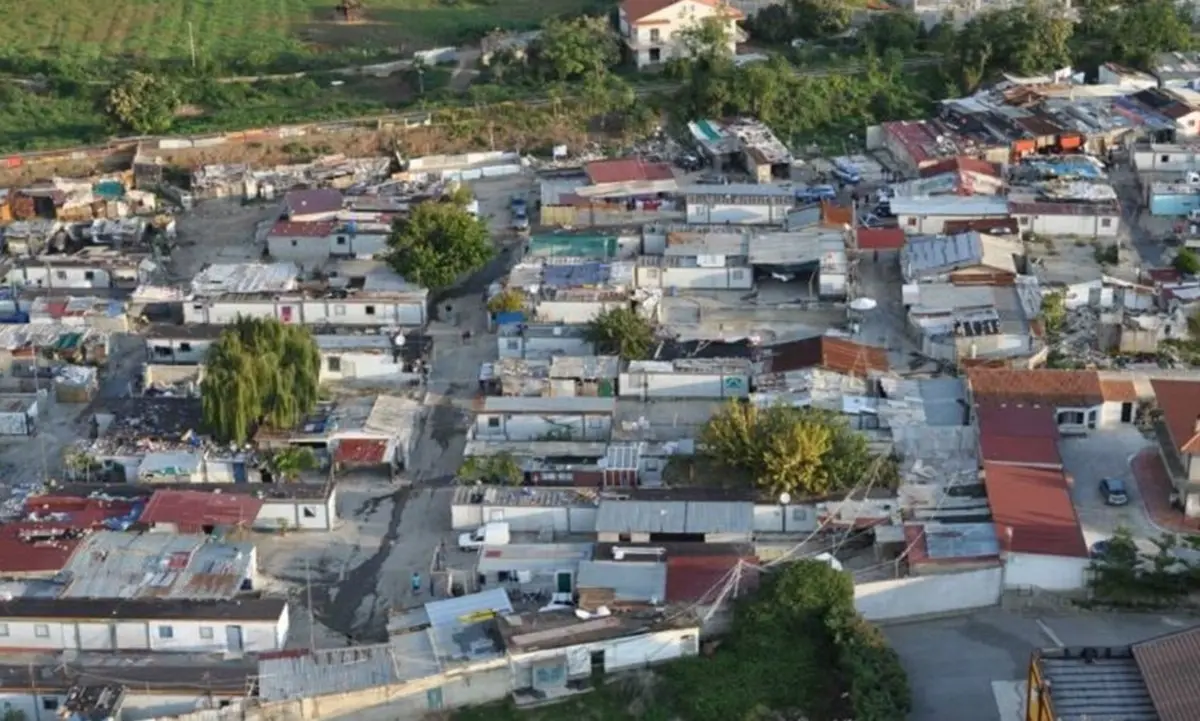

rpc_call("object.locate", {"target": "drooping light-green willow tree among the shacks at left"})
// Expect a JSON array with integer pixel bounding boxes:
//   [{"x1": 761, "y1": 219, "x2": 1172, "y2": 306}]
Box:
[{"x1": 200, "y1": 318, "x2": 320, "y2": 443}]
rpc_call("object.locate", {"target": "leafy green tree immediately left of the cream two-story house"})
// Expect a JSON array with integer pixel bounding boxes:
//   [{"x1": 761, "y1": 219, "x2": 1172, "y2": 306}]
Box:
[{"x1": 529, "y1": 17, "x2": 620, "y2": 80}]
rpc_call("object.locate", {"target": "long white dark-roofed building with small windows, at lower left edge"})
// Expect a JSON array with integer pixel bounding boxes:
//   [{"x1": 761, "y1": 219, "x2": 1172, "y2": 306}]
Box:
[{"x1": 0, "y1": 599, "x2": 289, "y2": 654}]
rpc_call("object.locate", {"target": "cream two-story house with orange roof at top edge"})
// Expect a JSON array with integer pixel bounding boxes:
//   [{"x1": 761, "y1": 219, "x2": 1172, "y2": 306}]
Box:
[{"x1": 619, "y1": 0, "x2": 745, "y2": 68}]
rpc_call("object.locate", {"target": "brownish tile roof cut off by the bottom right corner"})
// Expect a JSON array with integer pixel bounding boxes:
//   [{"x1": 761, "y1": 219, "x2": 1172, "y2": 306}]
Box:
[{"x1": 1133, "y1": 626, "x2": 1200, "y2": 721}]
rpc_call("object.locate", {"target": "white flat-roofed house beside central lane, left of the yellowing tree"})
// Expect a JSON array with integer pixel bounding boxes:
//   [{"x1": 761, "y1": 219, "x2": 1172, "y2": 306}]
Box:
[{"x1": 472, "y1": 396, "x2": 617, "y2": 440}]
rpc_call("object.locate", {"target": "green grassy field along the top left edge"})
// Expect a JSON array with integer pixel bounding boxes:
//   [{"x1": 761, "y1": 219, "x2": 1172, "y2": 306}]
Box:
[{"x1": 0, "y1": 0, "x2": 606, "y2": 67}]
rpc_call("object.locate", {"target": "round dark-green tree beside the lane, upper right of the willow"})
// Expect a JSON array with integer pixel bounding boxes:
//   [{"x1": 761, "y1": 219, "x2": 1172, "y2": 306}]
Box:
[{"x1": 388, "y1": 203, "x2": 492, "y2": 290}]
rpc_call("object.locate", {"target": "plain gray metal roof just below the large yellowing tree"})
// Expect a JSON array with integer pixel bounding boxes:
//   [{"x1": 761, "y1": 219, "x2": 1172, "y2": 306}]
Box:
[{"x1": 596, "y1": 500, "x2": 754, "y2": 534}]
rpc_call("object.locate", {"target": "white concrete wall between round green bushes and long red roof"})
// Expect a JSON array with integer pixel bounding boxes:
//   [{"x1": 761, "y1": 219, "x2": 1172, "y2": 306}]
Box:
[{"x1": 854, "y1": 566, "x2": 1003, "y2": 621}]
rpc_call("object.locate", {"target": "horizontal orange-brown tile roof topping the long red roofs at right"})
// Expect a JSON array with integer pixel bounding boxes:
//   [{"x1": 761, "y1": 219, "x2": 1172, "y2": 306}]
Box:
[{"x1": 967, "y1": 368, "x2": 1104, "y2": 407}]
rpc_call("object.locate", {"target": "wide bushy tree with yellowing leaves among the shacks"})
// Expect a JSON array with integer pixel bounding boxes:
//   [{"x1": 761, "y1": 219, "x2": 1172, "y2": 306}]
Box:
[{"x1": 700, "y1": 402, "x2": 895, "y2": 495}]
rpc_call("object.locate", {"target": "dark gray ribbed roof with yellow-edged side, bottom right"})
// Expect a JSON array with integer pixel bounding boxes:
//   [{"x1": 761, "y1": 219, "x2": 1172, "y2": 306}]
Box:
[{"x1": 1039, "y1": 649, "x2": 1158, "y2": 721}]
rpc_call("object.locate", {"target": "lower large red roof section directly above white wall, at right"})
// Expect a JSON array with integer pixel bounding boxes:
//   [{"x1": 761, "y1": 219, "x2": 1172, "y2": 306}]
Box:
[{"x1": 984, "y1": 462, "x2": 1087, "y2": 558}]
